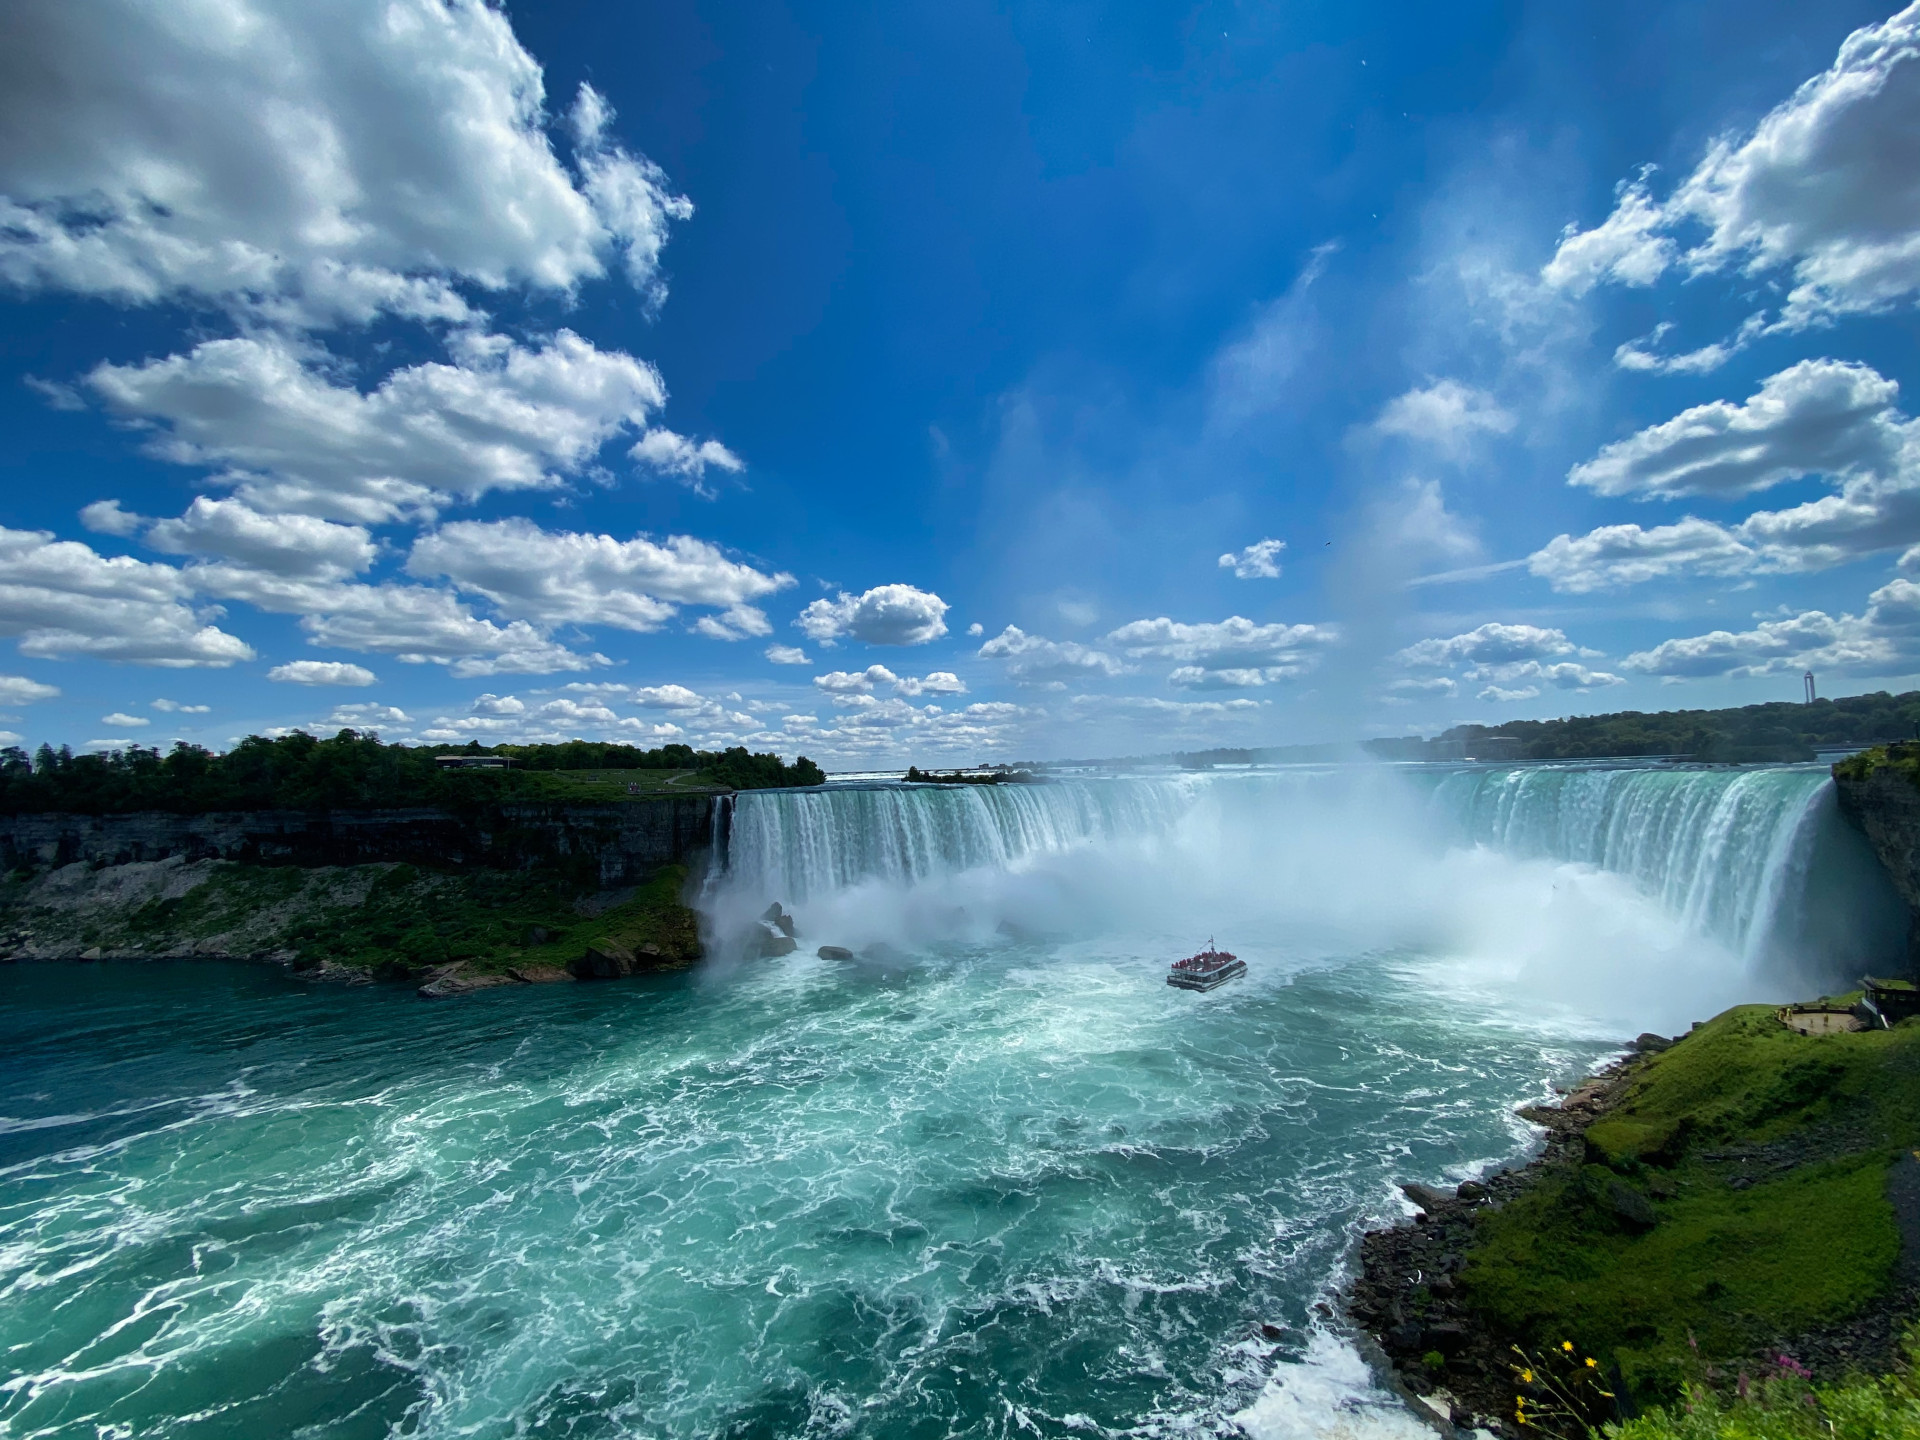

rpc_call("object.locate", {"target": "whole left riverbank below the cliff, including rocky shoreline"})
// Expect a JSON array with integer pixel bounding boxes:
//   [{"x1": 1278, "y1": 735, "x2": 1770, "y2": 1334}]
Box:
[{"x1": 0, "y1": 856, "x2": 701, "y2": 998}]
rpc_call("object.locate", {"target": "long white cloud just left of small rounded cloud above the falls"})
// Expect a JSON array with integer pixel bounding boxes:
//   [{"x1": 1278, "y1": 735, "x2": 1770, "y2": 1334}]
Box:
[{"x1": 407, "y1": 518, "x2": 793, "y2": 639}]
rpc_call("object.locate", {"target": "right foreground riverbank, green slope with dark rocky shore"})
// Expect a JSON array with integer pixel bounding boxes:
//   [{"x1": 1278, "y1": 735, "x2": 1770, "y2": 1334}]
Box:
[{"x1": 1346, "y1": 1006, "x2": 1920, "y2": 1434}]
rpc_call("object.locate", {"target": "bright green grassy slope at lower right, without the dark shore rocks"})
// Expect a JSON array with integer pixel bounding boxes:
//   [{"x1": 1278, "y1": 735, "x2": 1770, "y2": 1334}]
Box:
[{"x1": 1461, "y1": 1006, "x2": 1920, "y2": 1394}]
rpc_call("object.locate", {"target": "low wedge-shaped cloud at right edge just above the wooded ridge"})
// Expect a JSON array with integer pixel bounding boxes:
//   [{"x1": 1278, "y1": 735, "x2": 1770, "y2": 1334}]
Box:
[{"x1": 1620, "y1": 580, "x2": 1920, "y2": 680}]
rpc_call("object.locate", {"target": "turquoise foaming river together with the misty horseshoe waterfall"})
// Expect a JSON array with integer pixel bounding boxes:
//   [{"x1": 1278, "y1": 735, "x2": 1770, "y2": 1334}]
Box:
[{"x1": 0, "y1": 766, "x2": 1903, "y2": 1440}]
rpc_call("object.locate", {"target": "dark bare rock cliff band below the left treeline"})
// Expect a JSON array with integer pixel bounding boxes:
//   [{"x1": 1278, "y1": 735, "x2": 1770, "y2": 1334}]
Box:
[{"x1": 0, "y1": 795, "x2": 714, "y2": 887}]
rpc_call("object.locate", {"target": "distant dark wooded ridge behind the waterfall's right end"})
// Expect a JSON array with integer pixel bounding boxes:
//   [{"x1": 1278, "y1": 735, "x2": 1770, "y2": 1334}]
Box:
[{"x1": 1367, "y1": 689, "x2": 1920, "y2": 764}]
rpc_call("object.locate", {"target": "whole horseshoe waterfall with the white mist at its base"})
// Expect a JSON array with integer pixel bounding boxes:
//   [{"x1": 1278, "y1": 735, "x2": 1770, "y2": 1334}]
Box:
[{"x1": 720, "y1": 766, "x2": 1905, "y2": 1006}]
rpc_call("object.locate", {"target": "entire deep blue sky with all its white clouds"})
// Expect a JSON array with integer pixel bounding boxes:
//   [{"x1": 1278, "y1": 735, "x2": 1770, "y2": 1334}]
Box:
[{"x1": 0, "y1": 0, "x2": 1920, "y2": 768}]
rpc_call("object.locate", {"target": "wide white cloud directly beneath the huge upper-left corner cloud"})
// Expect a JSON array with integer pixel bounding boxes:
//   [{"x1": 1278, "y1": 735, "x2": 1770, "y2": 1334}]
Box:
[{"x1": 88, "y1": 330, "x2": 666, "y2": 524}]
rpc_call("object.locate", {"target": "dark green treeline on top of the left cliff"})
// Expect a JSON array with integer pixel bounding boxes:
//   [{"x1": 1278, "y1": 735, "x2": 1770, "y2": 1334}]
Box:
[{"x1": 0, "y1": 730, "x2": 826, "y2": 814}]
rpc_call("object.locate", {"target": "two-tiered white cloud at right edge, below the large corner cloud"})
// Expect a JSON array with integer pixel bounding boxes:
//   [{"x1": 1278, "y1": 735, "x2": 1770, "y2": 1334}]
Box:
[{"x1": 1528, "y1": 361, "x2": 1920, "y2": 593}]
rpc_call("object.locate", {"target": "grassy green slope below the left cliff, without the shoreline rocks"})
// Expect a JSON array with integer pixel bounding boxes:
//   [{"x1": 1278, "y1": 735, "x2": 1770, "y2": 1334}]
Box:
[{"x1": 0, "y1": 862, "x2": 699, "y2": 972}]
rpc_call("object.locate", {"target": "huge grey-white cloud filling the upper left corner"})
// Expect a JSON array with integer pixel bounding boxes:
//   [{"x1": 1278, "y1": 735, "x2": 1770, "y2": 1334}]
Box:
[{"x1": 0, "y1": 0, "x2": 691, "y2": 323}]
